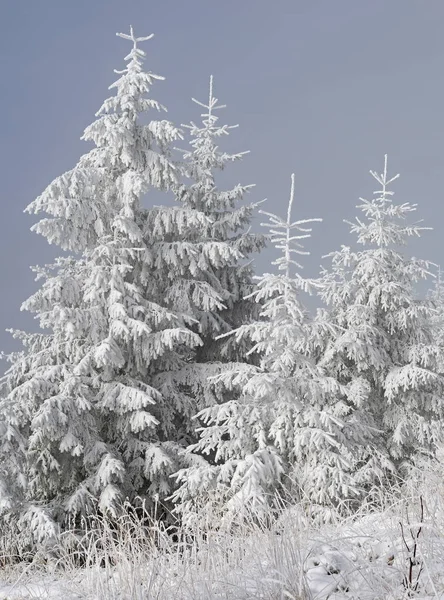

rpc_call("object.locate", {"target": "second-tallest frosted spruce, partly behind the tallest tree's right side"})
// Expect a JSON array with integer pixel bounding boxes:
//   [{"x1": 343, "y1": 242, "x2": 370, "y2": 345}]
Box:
[{"x1": 146, "y1": 77, "x2": 265, "y2": 452}]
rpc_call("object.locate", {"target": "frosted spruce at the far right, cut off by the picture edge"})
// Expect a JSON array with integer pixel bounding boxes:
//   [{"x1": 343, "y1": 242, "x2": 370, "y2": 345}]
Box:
[{"x1": 320, "y1": 156, "x2": 444, "y2": 482}]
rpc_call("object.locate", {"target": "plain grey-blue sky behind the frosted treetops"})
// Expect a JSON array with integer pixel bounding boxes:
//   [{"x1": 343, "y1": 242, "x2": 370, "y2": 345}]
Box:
[{"x1": 0, "y1": 0, "x2": 444, "y2": 360}]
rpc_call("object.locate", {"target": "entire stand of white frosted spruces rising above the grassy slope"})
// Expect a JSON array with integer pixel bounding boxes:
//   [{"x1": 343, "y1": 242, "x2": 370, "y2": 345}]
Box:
[{"x1": 0, "y1": 23, "x2": 444, "y2": 545}]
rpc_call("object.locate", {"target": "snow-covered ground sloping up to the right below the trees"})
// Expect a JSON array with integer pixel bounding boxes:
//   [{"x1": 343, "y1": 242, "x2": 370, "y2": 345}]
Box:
[{"x1": 0, "y1": 506, "x2": 444, "y2": 600}]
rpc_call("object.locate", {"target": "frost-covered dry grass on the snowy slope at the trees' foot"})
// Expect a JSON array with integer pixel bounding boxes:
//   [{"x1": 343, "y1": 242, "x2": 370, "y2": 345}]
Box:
[{"x1": 0, "y1": 473, "x2": 444, "y2": 600}]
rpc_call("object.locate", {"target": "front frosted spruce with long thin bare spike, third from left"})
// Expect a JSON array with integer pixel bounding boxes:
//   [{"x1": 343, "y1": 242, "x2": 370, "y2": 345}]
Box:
[{"x1": 175, "y1": 176, "x2": 366, "y2": 519}]
